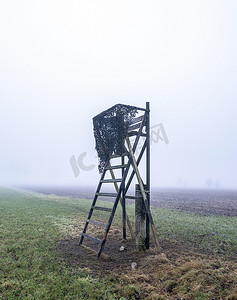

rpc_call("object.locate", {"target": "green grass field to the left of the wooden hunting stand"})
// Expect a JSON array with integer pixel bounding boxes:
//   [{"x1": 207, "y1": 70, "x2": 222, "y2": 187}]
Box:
[{"x1": 0, "y1": 189, "x2": 118, "y2": 299}]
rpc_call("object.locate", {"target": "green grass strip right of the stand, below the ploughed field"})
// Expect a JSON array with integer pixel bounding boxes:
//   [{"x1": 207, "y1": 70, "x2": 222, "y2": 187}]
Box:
[{"x1": 153, "y1": 208, "x2": 237, "y2": 257}]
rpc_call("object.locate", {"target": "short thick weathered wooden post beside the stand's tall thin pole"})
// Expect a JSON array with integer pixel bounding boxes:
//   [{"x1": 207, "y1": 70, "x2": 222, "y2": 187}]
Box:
[{"x1": 135, "y1": 184, "x2": 146, "y2": 251}]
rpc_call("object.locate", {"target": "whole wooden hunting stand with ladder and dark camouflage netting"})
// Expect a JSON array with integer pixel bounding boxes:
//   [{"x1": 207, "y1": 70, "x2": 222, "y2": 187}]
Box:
[{"x1": 79, "y1": 102, "x2": 160, "y2": 258}]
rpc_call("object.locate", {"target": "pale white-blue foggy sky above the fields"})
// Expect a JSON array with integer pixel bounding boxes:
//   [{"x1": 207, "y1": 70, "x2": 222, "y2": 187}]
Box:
[{"x1": 0, "y1": 0, "x2": 237, "y2": 188}]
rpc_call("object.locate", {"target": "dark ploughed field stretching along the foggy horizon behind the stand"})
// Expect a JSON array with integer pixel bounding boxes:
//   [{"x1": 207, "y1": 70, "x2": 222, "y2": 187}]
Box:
[{"x1": 21, "y1": 186, "x2": 237, "y2": 217}]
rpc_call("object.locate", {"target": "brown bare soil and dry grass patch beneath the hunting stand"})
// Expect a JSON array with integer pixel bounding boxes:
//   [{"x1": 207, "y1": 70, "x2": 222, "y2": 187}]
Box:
[{"x1": 58, "y1": 224, "x2": 237, "y2": 300}]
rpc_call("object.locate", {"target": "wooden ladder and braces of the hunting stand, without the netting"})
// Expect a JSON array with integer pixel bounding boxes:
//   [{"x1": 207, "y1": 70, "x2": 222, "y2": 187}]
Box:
[{"x1": 79, "y1": 103, "x2": 159, "y2": 258}]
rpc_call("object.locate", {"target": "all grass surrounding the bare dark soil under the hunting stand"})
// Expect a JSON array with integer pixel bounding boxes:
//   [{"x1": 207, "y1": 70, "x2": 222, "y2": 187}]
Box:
[{"x1": 0, "y1": 188, "x2": 237, "y2": 299}]
